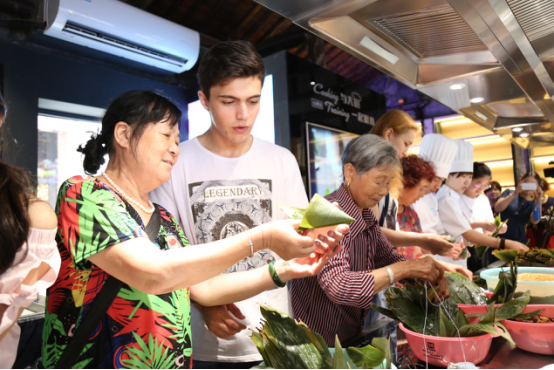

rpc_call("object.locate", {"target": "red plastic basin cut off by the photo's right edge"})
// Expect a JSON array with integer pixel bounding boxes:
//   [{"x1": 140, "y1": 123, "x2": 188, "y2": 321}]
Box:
[{"x1": 502, "y1": 305, "x2": 554, "y2": 355}]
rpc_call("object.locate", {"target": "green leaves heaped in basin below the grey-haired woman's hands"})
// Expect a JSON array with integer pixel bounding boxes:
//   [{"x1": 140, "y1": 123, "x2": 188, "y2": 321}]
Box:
[{"x1": 371, "y1": 283, "x2": 530, "y2": 343}]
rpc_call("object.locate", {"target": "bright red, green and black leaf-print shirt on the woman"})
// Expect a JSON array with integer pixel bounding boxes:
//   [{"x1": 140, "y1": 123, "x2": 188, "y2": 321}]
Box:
[{"x1": 42, "y1": 176, "x2": 192, "y2": 369}]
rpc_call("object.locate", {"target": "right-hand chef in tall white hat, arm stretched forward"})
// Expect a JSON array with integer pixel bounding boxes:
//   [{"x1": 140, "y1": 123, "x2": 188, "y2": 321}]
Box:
[{"x1": 437, "y1": 140, "x2": 528, "y2": 268}]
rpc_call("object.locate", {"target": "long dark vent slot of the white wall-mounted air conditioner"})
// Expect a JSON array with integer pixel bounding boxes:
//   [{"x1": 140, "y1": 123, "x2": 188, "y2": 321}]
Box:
[{"x1": 63, "y1": 22, "x2": 188, "y2": 67}]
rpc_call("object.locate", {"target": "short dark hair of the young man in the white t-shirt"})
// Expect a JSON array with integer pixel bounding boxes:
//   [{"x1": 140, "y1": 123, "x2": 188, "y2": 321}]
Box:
[{"x1": 198, "y1": 41, "x2": 265, "y2": 100}]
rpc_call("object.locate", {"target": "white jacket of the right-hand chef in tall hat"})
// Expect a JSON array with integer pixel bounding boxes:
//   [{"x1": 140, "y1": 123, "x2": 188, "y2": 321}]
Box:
[{"x1": 437, "y1": 185, "x2": 472, "y2": 268}]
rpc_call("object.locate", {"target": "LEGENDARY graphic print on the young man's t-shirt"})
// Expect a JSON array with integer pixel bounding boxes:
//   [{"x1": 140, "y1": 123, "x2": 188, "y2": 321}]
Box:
[{"x1": 188, "y1": 180, "x2": 275, "y2": 274}]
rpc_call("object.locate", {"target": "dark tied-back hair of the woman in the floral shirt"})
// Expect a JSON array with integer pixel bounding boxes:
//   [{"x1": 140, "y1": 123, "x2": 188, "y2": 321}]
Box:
[{"x1": 77, "y1": 90, "x2": 182, "y2": 175}]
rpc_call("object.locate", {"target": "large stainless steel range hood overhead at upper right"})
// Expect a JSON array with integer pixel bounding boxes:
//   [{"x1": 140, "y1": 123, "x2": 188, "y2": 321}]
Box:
[{"x1": 256, "y1": 0, "x2": 554, "y2": 148}]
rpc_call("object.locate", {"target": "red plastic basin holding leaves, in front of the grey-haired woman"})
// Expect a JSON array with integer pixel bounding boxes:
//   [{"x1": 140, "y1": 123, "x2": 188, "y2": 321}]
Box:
[{"x1": 399, "y1": 324, "x2": 493, "y2": 368}]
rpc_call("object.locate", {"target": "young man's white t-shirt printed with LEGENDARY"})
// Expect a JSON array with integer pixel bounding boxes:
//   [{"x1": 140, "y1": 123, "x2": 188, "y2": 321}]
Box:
[{"x1": 151, "y1": 138, "x2": 308, "y2": 362}]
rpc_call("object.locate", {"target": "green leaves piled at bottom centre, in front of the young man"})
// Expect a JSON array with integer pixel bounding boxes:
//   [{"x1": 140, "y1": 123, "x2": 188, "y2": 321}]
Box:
[{"x1": 252, "y1": 306, "x2": 391, "y2": 369}]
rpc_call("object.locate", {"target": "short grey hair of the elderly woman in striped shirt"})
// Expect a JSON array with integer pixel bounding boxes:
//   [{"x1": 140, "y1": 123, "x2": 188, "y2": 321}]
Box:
[{"x1": 342, "y1": 134, "x2": 401, "y2": 176}]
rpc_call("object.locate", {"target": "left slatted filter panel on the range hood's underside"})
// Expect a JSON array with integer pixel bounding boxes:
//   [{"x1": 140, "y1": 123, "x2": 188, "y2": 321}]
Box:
[{"x1": 368, "y1": 4, "x2": 488, "y2": 59}]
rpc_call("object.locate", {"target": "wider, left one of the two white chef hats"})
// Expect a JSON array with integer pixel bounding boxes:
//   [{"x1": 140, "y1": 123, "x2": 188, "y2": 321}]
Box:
[{"x1": 419, "y1": 134, "x2": 458, "y2": 178}]
